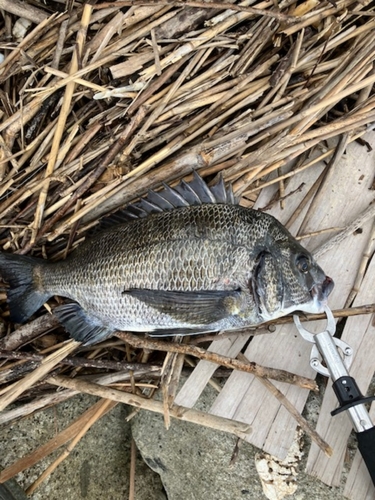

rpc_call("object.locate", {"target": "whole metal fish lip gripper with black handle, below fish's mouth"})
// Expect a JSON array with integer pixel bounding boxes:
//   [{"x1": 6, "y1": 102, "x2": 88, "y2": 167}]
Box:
[{"x1": 293, "y1": 306, "x2": 375, "y2": 485}]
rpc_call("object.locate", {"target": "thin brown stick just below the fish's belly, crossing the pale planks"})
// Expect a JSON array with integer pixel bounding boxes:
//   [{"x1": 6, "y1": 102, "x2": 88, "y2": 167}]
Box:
[{"x1": 116, "y1": 332, "x2": 317, "y2": 391}]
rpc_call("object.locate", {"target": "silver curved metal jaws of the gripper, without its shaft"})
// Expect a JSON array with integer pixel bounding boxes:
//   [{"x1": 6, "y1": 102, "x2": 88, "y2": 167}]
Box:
[{"x1": 293, "y1": 306, "x2": 353, "y2": 377}]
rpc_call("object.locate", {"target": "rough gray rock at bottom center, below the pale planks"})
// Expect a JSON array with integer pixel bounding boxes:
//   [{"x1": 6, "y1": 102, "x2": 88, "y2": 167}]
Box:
[{"x1": 132, "y1": 382, "x2": 350, "y2": 500}]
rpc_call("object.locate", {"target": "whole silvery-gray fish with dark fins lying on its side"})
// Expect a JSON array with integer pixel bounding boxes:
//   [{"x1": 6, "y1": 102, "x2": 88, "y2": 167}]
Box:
[{"x1": 0, "y1": 172, "x2": 334, "y2": 345}]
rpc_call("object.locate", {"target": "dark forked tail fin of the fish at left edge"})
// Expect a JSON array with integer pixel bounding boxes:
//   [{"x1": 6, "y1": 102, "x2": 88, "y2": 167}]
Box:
[{"x1": 0, "y1": 252, "x2": 51, "y2": 323}]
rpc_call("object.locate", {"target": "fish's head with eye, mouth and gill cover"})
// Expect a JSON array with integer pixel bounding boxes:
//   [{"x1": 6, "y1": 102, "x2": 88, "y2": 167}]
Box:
[{"x1": 250, "y1": 235, "x2": 334, "y2": 321}]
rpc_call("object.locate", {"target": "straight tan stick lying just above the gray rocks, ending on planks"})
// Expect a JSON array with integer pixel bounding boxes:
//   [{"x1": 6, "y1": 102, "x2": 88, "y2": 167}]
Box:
[{"x1": 47, "y1": 375, "x2": 251, "y2": 439}]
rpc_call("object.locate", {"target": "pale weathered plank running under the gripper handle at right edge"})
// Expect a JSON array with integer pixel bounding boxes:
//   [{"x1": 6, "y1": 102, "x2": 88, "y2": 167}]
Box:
[{"x1": 307, "y1": 260, "x2": 375, "y2": 486}]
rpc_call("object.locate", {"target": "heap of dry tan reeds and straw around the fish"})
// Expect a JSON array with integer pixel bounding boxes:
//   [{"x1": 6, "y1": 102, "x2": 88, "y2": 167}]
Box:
[{"x1": 0, "y1": 0, "x2": 375, "y2": 486}]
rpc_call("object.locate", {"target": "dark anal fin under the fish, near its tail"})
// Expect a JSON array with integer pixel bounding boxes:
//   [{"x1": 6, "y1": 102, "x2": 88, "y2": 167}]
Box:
[{"x1": 53, "y1": 302, "x2": 114, "y2": 345}]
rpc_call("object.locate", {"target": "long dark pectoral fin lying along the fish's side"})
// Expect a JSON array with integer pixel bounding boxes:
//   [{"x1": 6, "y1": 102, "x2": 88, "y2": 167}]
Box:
[{"x1": 123, "y1": 288, "x2": 241, "y2": 325}]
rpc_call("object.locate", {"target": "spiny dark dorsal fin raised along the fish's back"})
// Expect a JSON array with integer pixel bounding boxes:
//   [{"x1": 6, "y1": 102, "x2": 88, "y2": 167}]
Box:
[{"x1": 90, "y1": 171, "x2": 238, "y2": 235}]
